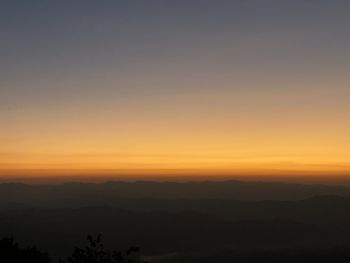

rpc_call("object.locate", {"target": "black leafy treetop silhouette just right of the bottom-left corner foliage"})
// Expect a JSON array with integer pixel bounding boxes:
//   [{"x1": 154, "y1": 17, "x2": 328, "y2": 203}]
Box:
[{"x1": 60, "y1": 234, "x2": 147, "y2": 263}]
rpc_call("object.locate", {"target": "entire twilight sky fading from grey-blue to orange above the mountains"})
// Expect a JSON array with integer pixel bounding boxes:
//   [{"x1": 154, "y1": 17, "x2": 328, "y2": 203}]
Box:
[{"x1": 0, "y1": 0, "x2": 350, "y2": 178}]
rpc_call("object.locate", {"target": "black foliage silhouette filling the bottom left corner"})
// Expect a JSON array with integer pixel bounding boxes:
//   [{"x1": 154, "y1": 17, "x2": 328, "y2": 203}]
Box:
[{"x1": 0, "y1": 237, "x2": 51, "y2": 263}]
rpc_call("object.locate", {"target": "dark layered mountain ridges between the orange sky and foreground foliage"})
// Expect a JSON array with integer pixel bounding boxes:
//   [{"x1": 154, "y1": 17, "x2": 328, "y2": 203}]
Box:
[{"x1": 0, "y1": 181, "x2": 350, "y2": 262}]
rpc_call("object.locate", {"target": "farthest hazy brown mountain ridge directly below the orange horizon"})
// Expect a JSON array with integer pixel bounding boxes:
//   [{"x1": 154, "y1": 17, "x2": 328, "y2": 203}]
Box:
[{"x1": 0, "y1": 181, "x2": 350, "y2": 207}]
